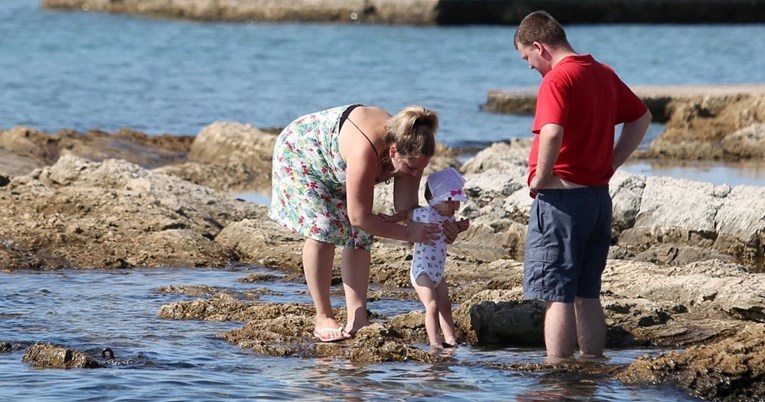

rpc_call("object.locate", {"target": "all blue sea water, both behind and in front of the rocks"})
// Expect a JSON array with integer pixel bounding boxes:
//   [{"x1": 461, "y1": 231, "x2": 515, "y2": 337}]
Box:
[{"x1": 0, "y1": 0, "x2": 765, "y2": 401}]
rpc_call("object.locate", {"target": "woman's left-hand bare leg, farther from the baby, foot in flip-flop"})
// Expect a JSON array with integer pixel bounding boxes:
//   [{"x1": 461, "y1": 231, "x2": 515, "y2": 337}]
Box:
[{"x1": 303, "y1": 239, "x2": 342, "y2": 338}]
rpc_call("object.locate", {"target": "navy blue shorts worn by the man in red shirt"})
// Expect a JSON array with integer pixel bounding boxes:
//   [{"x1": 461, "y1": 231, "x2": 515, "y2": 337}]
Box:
[{"x1": 523, "y1": 186, "x2": 612, "y2": 303}]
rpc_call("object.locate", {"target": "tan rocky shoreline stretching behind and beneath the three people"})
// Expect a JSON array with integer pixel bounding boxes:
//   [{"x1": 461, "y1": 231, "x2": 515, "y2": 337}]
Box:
[{"x1": 0, "y1": 118, "x2": 765, "y2": 401}]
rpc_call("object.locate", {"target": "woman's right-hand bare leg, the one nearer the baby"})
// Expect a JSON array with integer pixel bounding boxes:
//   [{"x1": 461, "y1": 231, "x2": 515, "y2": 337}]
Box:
[{"x1": 340, "y1": 247, "x2": 372, "y2": 335}]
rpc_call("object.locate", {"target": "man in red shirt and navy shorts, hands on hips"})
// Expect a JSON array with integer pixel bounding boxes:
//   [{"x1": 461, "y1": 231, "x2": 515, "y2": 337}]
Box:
[{"x1": 513, "y1": 11, "x2": 651, "y2": 358}]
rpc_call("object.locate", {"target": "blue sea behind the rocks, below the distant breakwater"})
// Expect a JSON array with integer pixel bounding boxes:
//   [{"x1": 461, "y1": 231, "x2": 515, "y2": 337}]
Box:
[{"x1": 0, "y1": 0, "x2": 765, "y2": 185}]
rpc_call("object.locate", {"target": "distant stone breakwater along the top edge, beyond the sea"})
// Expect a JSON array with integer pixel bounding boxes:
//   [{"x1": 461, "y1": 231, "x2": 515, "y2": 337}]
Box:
[{"x1": 41, "y1": 0, "x2": 765, "y2": 25}]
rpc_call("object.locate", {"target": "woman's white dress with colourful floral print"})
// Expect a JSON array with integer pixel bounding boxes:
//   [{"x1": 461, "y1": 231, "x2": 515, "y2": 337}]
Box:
[{"x1": 268, "y1": 105, "x2": 374, "y2": 250}]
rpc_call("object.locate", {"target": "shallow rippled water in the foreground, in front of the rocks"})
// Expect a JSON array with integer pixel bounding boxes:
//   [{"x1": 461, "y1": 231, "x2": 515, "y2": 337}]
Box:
[{"x1": 0, "y1": 267, "x2": 695, "y2": 401}]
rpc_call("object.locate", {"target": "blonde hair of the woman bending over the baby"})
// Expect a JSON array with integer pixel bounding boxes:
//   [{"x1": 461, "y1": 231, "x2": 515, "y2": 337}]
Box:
[{"x1": 385, "y1": 105, "x2": 438, "y2": 158}]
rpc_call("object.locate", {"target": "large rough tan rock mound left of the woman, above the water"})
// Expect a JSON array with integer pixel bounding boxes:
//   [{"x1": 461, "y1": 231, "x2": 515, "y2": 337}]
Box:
[{"x1": 0, "y1": 155, "x2": 262, "y2": 269}]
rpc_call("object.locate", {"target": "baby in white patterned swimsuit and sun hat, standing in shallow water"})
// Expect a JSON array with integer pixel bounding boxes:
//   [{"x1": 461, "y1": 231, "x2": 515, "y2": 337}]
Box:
[{"x1": 409, "y1": 168, "x2": 468, "y2": 348}]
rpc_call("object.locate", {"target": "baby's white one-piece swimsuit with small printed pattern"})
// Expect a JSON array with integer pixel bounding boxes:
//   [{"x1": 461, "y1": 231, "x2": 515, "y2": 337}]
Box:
[{"x1": 409, "y1": 207, "x2": 454, "y2": 286}]
